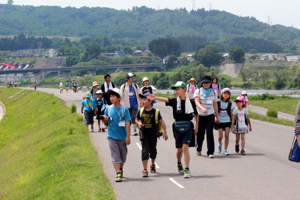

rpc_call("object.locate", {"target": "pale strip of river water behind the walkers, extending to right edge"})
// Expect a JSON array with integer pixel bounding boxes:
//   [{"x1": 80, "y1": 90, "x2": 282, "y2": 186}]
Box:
[{"x1": 156, "y1": 89, "x2": 300, "y2": 97}]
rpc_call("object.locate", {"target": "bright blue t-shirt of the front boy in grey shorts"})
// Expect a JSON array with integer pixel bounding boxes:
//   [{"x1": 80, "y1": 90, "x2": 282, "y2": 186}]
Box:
[{"x1": 104, "y1": 105, "x2": 131, "y2": 140}]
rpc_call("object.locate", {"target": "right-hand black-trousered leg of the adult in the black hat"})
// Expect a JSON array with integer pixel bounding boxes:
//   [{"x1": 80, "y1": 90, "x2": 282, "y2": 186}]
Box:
[{"x1": 206, "y1": 115, "x2": 215, "y2": 156}]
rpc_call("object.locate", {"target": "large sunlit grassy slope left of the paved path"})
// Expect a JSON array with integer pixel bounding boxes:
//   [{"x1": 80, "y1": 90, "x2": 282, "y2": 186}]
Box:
[{"x1": 0, "y1": 88, "x2": 115, "y2": 199}]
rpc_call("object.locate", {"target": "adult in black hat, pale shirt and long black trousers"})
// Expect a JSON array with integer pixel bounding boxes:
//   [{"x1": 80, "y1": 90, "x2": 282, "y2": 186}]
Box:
[{"x1": 194, "y1": 76, "x2": 220, "y2": 158}]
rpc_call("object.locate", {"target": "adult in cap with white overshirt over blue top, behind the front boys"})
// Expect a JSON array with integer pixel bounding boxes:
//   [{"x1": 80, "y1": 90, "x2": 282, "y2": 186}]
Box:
[{"x1": 120, "y1": 73, "x2": 140, "y2": 136}]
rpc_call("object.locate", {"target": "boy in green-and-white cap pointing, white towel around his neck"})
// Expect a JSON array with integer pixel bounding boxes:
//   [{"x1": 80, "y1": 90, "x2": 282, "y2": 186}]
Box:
[{"x1": 148, "y1": 81, "x2": 199, "y2": 178}]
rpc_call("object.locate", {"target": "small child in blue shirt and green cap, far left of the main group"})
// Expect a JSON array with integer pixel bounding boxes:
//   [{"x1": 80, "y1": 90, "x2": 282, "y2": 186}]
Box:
[{"x1": 81, "y1": 92, "x2": 97, "y2": 132}]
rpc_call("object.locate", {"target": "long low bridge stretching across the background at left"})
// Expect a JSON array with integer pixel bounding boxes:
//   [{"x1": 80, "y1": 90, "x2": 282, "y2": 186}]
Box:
[{"x1": 0, "y1": 63, "x2": 163, "y2": 83}]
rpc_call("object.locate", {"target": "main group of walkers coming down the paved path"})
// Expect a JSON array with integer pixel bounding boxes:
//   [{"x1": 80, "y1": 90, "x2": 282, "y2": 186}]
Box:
[{"x1": 81, "y1": 73, "x2": 252, "y2": 182}]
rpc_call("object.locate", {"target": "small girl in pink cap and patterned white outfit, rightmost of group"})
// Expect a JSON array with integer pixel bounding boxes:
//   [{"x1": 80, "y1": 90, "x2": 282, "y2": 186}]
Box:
[{"x1": 231, "y1": 96, "x2": 252, "y2": 155}]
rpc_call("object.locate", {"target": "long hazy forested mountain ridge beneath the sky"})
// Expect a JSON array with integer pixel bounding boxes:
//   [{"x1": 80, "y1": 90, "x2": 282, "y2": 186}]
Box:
[{"x1": 0, "y1": 4, "x2": 300, "y2": 49}]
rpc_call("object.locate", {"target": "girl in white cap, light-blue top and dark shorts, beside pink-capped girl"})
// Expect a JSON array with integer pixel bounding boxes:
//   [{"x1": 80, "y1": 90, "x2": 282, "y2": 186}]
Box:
[{"x1": 216, "y1": 88, "x2": 233, "y2": 156}]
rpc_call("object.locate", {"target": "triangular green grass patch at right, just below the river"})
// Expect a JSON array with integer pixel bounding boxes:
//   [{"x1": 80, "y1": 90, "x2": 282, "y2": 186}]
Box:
[{"x1": 249, "y1": 98, "x2": 299, "y2": 115}]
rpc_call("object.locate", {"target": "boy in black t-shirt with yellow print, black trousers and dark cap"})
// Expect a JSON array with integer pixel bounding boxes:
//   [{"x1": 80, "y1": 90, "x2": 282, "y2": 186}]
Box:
[{"x1": 135, "y1": 92, "x2": 168, "y2": 177}]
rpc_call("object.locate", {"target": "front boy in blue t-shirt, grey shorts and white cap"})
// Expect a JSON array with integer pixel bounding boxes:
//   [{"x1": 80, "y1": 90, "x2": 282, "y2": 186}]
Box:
[{"x1": 103, "y1": 88, "x2": 131, "y2": 182}]
